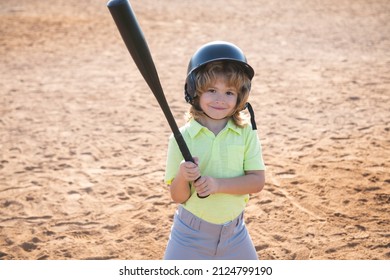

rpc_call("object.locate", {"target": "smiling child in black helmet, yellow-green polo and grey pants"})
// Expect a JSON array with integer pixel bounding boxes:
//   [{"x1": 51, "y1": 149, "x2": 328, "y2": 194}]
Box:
[{"x1": 164, "y1": 41, "x2": 265, "y2": 260}]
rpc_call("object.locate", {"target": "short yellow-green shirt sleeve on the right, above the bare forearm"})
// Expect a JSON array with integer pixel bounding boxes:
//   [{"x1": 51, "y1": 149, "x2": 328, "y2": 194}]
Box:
[{"x1": 244, "y1": 129, "x2": 265, "y2": 171}]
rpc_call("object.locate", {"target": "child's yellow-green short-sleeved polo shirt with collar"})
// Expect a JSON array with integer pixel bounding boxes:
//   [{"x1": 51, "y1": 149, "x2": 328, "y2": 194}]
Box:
[{"x1": 165, "y1": 119, "x2": 265, "y2": 224}]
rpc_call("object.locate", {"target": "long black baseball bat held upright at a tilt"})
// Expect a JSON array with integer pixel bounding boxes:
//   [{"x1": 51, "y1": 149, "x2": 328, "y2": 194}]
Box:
[{"x1": 107, "y1": 0, "x2": 204, "y2": 198}]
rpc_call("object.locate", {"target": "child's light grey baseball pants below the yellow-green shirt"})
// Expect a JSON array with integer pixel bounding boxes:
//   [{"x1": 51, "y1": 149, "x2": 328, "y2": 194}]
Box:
[{"x1": 164, "y1": 206, "x2": 258, "y2": 260}]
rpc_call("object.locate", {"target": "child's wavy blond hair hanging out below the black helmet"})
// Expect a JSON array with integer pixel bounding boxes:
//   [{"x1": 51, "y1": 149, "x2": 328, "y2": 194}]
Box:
[{"x1": 186, "y1": 61, "x2": 251, "y2": 127}]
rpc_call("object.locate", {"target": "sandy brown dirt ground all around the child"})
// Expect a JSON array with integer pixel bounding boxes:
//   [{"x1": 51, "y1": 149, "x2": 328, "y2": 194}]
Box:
[{"x1": 0, "y1": 0, "x2": 390, "y2": 260}]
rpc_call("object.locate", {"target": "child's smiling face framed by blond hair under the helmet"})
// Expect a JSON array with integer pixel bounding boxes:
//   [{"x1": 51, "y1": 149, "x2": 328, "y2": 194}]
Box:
[{"x1": 199, "y1": 75, "x2": 238, "y2": 120}]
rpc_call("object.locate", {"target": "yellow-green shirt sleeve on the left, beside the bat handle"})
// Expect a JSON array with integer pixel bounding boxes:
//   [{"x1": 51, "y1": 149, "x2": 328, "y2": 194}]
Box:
[{"x1": 164, "y1": 134, "x2": 183, "y2": 185}]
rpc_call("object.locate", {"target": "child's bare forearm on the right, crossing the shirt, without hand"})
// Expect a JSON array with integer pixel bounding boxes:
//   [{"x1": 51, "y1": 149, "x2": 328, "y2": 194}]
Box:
[{"x1": 216, "y1": 171, "x2": 265, "y2": 194}]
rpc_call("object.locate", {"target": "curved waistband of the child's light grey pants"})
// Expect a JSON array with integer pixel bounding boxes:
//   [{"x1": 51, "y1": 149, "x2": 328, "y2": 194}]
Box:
[{"x1": 176, "y1": 205, "x2": 244, "y2": 234}]
